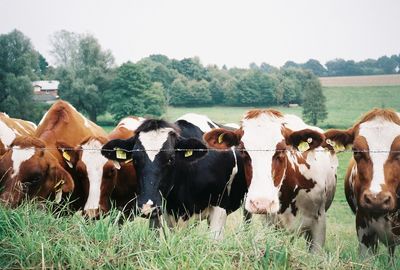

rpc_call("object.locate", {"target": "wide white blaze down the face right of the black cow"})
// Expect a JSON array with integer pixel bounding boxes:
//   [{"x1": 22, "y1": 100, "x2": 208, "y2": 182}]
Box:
[{"x1": 242, "y1": 114, "x2": 284, "y2": 213}]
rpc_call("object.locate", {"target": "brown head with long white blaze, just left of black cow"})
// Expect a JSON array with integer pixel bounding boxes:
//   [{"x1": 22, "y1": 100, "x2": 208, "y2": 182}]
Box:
[{"x1": 57, "y1": 136, "x2": 120, "y2": 218}]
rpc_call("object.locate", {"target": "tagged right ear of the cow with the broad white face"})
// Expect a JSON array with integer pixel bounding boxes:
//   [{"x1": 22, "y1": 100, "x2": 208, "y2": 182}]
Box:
[{"x1": 285, "y1": 129, "x2": 325, "y2": 152}]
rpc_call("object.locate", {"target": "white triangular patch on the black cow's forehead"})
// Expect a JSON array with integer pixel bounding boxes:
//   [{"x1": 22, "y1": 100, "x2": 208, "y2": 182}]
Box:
[{"x1": 139, "y1": 128, "x2": 174, "y2": 162}]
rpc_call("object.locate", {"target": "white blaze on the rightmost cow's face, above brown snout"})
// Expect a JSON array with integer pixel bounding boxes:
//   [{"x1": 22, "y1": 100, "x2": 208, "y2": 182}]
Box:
[{"x1": 359, "y1": 117, "x2": 400, "y2": 193}]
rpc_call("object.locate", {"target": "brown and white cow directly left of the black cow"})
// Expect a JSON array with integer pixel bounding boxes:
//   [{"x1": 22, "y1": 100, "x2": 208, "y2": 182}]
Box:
[{"x1": 58, "y1": 116, "x2": 144, "y2": 218}]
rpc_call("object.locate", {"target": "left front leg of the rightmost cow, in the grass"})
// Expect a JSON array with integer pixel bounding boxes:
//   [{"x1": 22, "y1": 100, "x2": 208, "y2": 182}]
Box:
[{"x1": 356, "y1": 212, "x2": 378, "y2": 257}]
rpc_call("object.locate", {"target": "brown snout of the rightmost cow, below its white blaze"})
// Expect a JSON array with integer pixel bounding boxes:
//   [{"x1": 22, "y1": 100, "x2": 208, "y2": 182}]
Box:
[{"x1": 360, "y1": 190, "x2": 396, "y2": 212}]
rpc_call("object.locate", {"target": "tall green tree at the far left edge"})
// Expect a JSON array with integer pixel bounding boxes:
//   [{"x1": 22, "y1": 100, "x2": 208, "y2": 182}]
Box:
[{"x1": 0, "y1": 30, "x2": 40, "y2": 121}]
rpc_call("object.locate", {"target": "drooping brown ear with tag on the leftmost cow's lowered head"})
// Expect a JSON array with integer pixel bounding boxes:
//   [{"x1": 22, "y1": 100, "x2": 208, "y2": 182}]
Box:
[{"x1": 49, "y1": 164, "x2": 75, "y2": 203}]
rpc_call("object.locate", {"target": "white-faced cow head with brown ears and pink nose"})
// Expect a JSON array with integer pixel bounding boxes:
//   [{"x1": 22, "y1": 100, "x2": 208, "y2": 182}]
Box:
[{"x1": 204, "y1": 110, "x2": 323, "y2": 214}]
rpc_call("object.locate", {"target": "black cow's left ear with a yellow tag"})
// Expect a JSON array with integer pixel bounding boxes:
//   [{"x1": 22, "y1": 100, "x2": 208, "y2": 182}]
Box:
[{"x1": 101, "y1": 137, "x2": 135, "y2": 162}]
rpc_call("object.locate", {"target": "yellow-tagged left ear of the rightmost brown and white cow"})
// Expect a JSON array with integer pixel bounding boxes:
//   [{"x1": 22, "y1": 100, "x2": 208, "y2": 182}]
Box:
[{"x1": 323, "y1": 128, "x2": 354, "y2": 152}]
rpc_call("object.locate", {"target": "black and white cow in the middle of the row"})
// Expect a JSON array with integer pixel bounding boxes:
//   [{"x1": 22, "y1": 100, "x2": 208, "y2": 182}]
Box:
[{"x1": 102, "y1": 118, "x2": 247, "y2": 239}]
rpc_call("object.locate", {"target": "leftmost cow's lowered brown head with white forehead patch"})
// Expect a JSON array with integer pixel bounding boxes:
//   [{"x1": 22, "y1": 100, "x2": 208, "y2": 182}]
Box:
[{"x1": 0, "y1": 136, "x2": 74, "y2": 206}]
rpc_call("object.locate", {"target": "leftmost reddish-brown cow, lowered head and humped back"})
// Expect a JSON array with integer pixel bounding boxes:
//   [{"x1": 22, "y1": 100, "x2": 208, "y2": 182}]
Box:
[{"x1": 0, "y1": 101, "x2": 106, "y2": 207}]
